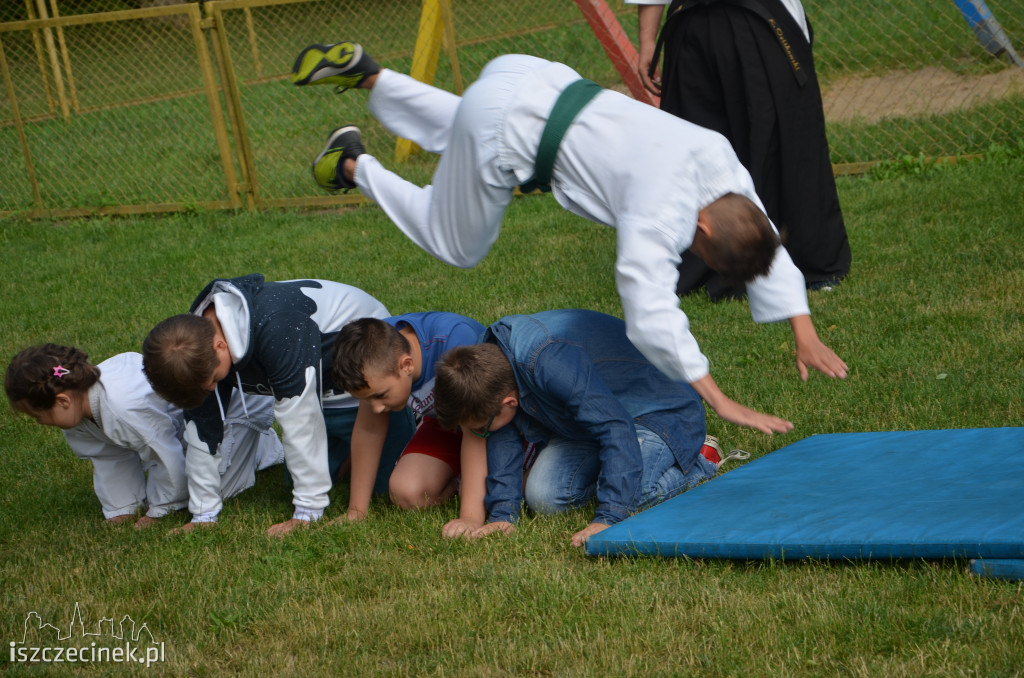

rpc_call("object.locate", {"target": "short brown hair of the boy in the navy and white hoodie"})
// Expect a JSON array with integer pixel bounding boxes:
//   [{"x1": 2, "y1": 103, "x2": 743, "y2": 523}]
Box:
[{"x1": 142, "y1": 313, "x2": 217, "y2": 410}]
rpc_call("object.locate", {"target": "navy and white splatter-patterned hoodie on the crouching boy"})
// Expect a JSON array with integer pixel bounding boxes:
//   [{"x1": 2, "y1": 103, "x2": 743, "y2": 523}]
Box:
[{"x1": 185, "y1": 273, "x2": 389, "y2": 520}]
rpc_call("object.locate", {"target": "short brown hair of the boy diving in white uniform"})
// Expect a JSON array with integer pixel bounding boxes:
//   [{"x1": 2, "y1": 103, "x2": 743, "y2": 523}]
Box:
[{"x1": 705, "y1": 193, "x2": 781, "y2": 287}]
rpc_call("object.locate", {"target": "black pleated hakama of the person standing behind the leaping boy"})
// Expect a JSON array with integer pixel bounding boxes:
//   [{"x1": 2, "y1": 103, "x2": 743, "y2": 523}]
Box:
[{"x1": 662, "y1": 0, "x2": 850, "y2": 298}]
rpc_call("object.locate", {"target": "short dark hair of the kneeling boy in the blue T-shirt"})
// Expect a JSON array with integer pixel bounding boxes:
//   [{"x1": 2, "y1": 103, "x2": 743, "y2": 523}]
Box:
[{"x1": 332, "y1": 317, "x2": 412, "y2": 392}]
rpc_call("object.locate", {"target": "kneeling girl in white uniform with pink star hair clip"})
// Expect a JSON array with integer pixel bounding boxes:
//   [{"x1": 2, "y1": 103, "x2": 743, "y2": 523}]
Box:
[{"x1": 4, "y1": 344, "x2": 285, "y2": 527}]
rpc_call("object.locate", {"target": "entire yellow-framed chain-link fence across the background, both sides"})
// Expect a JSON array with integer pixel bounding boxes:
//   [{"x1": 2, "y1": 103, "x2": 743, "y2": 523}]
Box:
[{"x1": 0, "y1": 0, "x2": 1024, "y2": 215}]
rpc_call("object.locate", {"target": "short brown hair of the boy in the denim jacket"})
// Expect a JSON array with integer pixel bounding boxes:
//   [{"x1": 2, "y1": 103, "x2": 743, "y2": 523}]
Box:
[{"x1": 434, "y1": 343, "x2": 516, "y2": 430}]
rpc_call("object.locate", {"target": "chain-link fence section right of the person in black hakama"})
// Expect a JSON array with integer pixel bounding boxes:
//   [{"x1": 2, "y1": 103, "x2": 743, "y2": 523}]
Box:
[{"x1": 804, "y1": 0, "x2": 1024, "y2": 169}]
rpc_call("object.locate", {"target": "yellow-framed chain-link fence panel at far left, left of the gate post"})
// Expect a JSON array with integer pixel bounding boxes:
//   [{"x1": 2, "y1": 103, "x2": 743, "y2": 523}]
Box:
[{"x1": 0, "y1": 5, "x2": 238, "y2": 211}]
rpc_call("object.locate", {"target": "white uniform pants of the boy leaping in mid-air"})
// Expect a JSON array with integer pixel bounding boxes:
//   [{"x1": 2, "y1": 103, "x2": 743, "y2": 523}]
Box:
[{"x1": 355, "y1": 54, "x2": 547, "y2": 268}]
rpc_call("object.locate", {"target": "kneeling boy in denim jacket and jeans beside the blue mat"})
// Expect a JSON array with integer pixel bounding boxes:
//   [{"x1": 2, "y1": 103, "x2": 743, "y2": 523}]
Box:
[{"x1": 434, "y1": 310, "x2": 717, "y2": 546}]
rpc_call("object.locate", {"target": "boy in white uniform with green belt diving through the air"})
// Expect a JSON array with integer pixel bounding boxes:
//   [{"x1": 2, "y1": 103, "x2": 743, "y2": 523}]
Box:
[{"x1": 292, "y1": 42, "x2": 847, "y2": 433}]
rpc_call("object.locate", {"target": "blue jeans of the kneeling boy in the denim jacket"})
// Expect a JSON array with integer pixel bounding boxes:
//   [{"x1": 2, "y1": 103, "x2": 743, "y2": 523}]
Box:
[{"x1": 523, "y1": 425, "x2": 718, "y2": 514}]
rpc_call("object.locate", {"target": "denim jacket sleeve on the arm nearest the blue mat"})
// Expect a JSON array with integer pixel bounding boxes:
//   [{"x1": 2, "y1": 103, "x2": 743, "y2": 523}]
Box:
[{"x1": 534, "y1": 342, "x2": 643, "y2": 525}]
